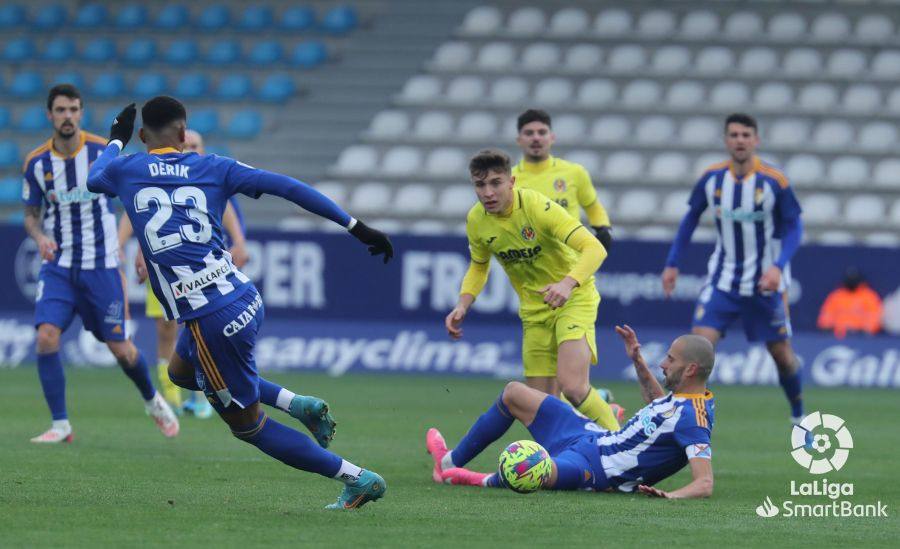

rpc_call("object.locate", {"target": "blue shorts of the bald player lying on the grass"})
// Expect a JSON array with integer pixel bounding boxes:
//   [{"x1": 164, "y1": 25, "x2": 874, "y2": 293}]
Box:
[{"x1": 528, "y1": 396, "x2": 609, "y2": 490}]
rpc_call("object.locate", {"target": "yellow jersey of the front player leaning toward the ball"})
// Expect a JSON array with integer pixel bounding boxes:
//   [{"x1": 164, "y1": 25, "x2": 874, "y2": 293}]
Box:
[{"x1": 466, "y1": 189, "x2": 605, "y2": 318}]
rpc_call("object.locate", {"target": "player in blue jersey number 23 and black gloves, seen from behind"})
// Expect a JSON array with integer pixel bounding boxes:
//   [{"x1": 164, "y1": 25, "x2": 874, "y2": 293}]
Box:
[{"x1": 88, "y1": 96, "x2": 393, "y2": 509}]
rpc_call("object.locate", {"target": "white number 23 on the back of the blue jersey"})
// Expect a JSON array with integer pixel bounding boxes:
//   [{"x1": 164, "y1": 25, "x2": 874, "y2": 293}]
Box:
[{"x1": 134, "y1": 187, "x2": 212, "y2": 253}]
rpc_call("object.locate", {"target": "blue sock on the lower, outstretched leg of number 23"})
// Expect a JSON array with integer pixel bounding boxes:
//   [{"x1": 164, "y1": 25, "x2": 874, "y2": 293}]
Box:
[{"x1": 232, "y1": 413, "x2": 343, "y2": 478}]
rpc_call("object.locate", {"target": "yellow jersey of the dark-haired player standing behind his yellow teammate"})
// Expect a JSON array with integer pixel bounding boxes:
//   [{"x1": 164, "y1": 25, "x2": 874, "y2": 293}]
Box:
[{"x1": 512, "y1": 156, "x2": 610, "y2": 226}]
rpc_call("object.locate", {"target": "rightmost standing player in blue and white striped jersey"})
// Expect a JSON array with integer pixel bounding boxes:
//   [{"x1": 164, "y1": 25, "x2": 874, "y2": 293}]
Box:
[{"x1": 662, "y1": 114, "x2": 803, "y2": 432}]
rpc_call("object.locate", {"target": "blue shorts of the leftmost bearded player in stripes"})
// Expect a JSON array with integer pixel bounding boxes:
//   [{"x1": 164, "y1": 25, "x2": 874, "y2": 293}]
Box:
[{"x1": 34, "y1": 263, "x2": 128, "y2": 341}]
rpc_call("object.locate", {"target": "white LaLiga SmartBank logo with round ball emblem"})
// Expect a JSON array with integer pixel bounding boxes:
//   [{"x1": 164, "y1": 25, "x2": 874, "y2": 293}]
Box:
[{"x1": 756, "y1": 412, "x2": 887, "y2": 518}]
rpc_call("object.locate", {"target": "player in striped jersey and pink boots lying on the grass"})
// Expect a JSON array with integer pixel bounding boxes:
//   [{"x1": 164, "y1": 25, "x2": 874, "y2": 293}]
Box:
[{"x1": 426, "y1": 326, "x2": 715, "y2": 498}]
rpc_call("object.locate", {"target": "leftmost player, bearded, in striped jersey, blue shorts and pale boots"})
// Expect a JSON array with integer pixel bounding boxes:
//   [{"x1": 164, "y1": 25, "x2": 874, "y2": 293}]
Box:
[{"x1": 22, "y1": 84, "x2": 179, "y2": 443}]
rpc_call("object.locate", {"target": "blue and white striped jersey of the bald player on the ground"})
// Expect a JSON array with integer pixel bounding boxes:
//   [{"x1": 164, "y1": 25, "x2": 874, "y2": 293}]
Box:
[{"x1": 597, "y1": 391, "x2": 715, "y2": 492}]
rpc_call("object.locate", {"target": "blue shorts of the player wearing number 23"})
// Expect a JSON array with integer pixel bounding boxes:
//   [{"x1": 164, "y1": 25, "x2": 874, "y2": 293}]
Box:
[{"x1": 175, "y1": 286, "x2": 265, "y2": 411}]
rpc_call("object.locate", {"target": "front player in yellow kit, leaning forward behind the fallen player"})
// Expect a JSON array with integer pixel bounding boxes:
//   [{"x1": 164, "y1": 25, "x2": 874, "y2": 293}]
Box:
[{"x1": 444, "y1": 150, "x2": 619, "y2": 430}]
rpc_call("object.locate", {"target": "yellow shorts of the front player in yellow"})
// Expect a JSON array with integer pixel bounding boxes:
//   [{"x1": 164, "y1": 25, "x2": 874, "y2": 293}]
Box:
[{"x1": 522, "y1": 288, "x2": 600, "y2": 377}]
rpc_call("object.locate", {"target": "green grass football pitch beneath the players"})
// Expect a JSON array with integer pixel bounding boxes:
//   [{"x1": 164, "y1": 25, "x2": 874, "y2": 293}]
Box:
[{"x1": 0, "y1": 368, "x2": 900, "y2": 548}]
